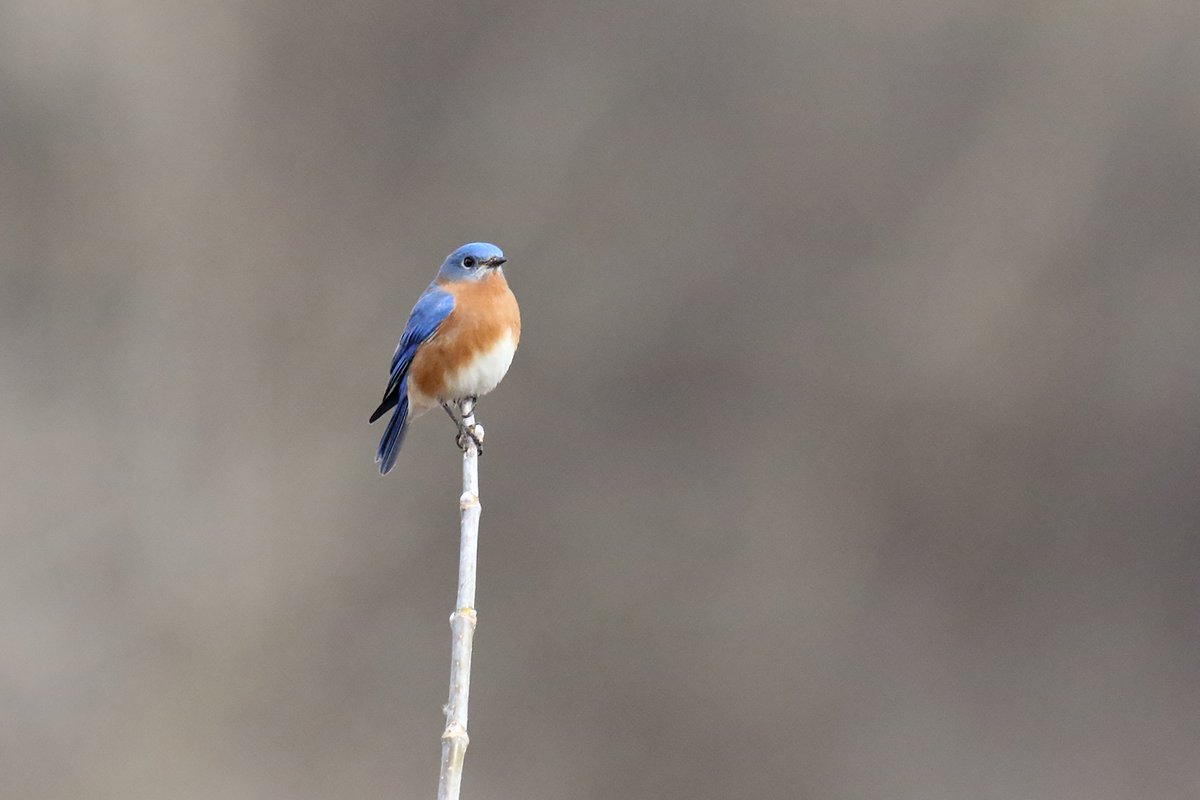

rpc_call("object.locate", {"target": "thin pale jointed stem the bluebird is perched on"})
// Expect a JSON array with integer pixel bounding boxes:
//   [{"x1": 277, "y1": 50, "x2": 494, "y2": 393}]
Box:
[{"x1": 438, "y1": 399, "x2": 484, "y2": 800}]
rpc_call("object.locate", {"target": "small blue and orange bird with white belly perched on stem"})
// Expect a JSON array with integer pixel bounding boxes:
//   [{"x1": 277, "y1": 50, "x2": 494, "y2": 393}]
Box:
[{"x1": 370, "y1": 242, "x2": 521, "y2": 475}]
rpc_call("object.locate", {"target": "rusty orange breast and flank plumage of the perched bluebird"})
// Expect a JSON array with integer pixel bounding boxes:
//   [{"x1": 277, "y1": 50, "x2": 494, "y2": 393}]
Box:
[{"x1": 408, "y1": 270, "x2": 521, "y2": 397}]
